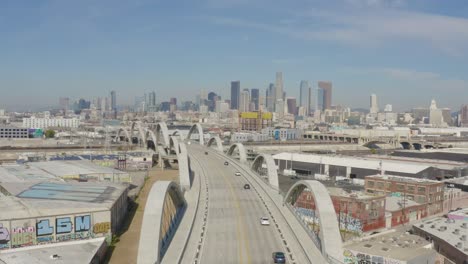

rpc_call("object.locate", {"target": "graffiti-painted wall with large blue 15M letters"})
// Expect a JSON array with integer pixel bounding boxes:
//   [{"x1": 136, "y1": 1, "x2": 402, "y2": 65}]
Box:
[{"x1": 0, "y1": 212, "x2": 111, "y2": 250}]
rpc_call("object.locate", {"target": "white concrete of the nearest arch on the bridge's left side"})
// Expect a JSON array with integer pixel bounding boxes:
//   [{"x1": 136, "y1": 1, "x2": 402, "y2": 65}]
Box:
[{"x1": 137, "y1": 181, "x2": 187, "y2": 264}]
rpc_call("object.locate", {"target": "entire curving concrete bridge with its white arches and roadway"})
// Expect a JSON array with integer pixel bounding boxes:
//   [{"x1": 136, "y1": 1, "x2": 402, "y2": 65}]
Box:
[{"x1": 118, "y1": 122, "x2": 343, "y2": 264}]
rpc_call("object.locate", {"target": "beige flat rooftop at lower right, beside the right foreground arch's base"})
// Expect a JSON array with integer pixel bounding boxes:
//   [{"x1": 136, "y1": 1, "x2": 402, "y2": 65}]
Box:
[{"x1": 344, "y1": 231, "x2": 435, "y2": 261}]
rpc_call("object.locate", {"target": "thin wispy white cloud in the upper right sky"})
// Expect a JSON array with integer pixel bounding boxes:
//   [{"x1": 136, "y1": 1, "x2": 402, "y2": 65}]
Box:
[{"x1": 210, "y1": 4, "x2": 468, "y2": 56}]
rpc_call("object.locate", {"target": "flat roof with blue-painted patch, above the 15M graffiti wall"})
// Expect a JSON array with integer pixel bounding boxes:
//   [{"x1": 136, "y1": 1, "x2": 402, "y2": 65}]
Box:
[{"x1": 0, "y1": 182, "x2": 127, "y2": 220}]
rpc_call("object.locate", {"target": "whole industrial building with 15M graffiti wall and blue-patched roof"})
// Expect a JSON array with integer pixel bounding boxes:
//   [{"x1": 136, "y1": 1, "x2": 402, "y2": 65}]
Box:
[{"x1": 0, "y1": 181, "x2": 128, "y2": 254}]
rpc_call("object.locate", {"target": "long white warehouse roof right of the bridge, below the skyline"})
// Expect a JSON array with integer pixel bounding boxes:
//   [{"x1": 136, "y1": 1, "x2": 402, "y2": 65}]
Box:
[{"x1": 273, "y1": 152, "x2": 431, "y2": 174}]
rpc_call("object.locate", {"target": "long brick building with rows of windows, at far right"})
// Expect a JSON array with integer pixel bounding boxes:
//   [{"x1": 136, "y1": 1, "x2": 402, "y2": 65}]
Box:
[{"x1": 365, "y1": 175, "x2": 444, "y2": 216}]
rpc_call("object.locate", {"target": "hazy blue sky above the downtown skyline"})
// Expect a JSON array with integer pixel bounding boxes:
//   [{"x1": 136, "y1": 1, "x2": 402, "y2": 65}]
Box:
[{"x1": 0, "y1": 0, "x2": 468, "y2": 111}]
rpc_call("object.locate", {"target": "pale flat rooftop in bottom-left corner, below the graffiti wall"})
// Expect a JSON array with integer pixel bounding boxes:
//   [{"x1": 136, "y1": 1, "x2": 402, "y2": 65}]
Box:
[{"x1": 0, "y1": 237, "x2": 105, "y2": 264}]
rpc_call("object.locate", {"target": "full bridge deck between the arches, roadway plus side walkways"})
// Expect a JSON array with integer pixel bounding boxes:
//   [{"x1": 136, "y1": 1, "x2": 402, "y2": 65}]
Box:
[{"x1": 177, "y1": 144, "x2": 321, "y2": 264}]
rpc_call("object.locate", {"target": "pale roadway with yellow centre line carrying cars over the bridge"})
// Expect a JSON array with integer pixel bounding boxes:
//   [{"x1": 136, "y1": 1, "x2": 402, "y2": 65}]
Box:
[{"x1": 182, "y1": 144, "x2": 302, "y2": 264}]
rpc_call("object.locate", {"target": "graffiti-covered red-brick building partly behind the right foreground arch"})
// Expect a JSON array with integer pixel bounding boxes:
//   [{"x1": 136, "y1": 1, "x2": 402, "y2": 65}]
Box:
[{"x1": 295, "y1": 187, "x2": 385, "y2": 235}]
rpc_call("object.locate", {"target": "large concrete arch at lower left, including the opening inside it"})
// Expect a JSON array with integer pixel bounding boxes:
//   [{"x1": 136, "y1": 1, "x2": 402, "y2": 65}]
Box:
[{"x1": 137, "y1": 181, "x2": 187, "y2": 264}]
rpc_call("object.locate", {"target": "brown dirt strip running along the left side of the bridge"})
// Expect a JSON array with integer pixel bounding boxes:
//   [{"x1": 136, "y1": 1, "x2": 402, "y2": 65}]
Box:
[{"x1": 109, "y1": 168, "x2": 179, "y2": 264}]
